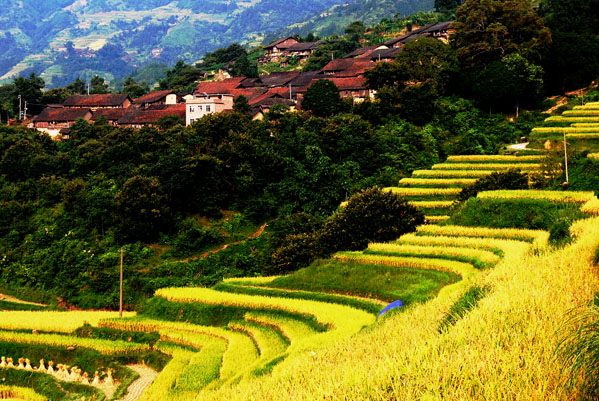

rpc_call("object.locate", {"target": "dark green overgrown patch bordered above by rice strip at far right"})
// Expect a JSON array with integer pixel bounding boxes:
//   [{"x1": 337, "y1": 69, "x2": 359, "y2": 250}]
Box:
[{"x1": 448, "y1": 198, "x2": 584, "y2": 245}]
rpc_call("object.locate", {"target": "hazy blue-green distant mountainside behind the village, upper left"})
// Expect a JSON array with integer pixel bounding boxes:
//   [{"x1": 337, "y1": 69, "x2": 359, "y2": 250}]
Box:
[{"x1": 0, "y1": 0, "x2": 433, "y2": 87}]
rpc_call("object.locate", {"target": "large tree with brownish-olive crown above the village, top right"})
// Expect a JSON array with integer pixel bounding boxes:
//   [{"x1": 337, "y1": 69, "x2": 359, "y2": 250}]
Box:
[{"x1": 453, "y1": 0, "x2": 551, "y2": 70}]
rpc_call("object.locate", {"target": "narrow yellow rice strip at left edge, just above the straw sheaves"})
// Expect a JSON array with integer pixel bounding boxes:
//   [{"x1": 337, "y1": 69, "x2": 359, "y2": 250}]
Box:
[{"x1": 0, "y1": 331, "x2": 150, "y2": 355}]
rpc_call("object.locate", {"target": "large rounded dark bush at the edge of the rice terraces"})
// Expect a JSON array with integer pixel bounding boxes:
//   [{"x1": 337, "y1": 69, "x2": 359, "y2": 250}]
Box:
[{"x1": 318, "y1": 187, "x2": 424, "y2": 255}]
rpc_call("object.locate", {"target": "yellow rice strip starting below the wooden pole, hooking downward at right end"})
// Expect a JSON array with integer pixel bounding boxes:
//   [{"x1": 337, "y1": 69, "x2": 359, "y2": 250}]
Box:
[{"x1": 100, "y1": 318, "x2": 258, "y2": 378}]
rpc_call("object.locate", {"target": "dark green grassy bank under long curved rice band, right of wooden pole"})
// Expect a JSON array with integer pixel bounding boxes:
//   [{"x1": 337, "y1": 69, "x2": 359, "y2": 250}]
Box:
[{"x1": 139, "y1": 297, "x2": 327, "y2": 331}]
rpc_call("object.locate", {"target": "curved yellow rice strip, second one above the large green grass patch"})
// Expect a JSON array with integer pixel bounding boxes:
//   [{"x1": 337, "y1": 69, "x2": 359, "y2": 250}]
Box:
[{"x1": 368, "y1": 243, "x2": 500, "y2": 263}]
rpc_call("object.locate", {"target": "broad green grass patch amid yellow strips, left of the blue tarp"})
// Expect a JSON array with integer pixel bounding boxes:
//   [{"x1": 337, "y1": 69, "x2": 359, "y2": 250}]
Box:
[{"x1": 268, "y1": 259, "x2": 460, "y2": 304}]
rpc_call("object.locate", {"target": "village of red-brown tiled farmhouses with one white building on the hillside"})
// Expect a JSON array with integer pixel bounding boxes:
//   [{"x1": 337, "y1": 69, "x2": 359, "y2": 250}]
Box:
[{"x1": 33, "y1": 22, "x2": 451, "y2": 138}]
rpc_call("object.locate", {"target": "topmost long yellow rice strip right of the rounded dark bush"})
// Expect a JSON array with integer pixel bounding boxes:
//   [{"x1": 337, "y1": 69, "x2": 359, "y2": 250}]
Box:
[{"x1": 416, "y1": 225, "x2": 549, "y2": 248}]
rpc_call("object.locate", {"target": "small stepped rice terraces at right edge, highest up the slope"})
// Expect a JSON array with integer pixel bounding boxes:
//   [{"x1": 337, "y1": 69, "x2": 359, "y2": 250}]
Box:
[{"x1": 531, "y1": 102, "x2": 599, "y2": 151}]
